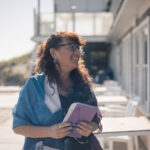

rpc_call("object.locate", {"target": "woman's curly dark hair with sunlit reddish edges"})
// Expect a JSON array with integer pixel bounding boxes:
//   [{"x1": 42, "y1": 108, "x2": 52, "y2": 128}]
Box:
[{"x1": 34, "y1": 31, "x2": 91, "y2": 90}]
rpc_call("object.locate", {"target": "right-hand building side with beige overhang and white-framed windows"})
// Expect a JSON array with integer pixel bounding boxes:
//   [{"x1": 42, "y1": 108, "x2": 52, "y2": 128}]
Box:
[{"x1": 108, "y1": 0, "x2": 150, "y2": 149}]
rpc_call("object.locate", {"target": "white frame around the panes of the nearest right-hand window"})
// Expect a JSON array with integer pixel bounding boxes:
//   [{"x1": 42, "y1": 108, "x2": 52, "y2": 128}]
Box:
[{"x1": 132, "y1": 16, "x2": 150, "y2": 116}]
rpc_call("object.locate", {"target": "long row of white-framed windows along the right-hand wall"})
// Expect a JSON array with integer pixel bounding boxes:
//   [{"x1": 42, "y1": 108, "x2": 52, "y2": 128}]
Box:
[{"x1": 110, "y1": 17, "x2": 150, "y2": 116}]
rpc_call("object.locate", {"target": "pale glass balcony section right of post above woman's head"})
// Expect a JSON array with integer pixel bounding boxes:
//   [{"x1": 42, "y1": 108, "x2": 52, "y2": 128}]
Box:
[{"x1": 75, "y1": 13, "x2": 113, "y2": 36}]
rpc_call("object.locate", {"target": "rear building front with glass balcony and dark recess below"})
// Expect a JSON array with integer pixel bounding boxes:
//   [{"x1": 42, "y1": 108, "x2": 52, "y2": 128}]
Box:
[{"x1": 30, "y1": 0, "x2": 113, "y2": 76}]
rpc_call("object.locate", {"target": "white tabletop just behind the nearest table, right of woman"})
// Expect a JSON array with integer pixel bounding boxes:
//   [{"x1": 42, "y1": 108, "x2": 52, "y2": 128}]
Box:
[{"x1": 96, "y1": 96, "x2": 128, "y2": 105}]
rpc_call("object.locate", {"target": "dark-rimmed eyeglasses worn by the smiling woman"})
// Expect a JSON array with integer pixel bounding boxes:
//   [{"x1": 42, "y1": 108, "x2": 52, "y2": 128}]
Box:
[{"x1": 57, "y1": 43, "x2": 83, "y2": 52}]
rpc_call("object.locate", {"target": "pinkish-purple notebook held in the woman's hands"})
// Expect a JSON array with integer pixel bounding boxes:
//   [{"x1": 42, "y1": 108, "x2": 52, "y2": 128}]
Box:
[{"x1": 63, "y1": 103, "x2": 98, "y2": 138}]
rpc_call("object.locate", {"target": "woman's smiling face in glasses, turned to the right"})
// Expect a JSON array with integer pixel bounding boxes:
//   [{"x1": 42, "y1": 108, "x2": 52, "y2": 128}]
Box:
[{"x1": 51, "y1": 39, "x2": 81, "y2": 72}]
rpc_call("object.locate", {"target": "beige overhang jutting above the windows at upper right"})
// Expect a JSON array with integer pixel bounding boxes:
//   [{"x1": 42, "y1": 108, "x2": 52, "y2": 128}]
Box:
[{"x1": 108, "y1": 0, "x2": 150, "y2": 42}]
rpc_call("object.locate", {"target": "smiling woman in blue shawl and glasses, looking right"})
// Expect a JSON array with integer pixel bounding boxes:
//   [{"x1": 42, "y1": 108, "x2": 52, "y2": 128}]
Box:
[{"x1": 13, "y1": 32, "x2": 100, "y2": 150}]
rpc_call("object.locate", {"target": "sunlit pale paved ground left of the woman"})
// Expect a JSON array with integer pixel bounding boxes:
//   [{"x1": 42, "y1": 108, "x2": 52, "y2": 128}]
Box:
[{"x1": 0, "y1": 87, "x2": 146, "y2": 150}]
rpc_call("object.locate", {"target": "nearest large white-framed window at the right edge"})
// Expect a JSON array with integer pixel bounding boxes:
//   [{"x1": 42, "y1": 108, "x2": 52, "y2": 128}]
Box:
[{"x1": 133, "y1": 18, "x2": 150, "y2": 115}]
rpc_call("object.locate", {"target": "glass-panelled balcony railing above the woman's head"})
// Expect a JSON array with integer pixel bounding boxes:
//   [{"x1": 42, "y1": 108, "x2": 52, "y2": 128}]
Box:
[{"x1": 34, "y1": 12, "x2": 113, "y2": 36}]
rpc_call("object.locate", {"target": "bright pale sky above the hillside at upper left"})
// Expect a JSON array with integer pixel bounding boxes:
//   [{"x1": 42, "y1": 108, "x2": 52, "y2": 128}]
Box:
[{"x1": 0, "y1": 0, "x2": 37, "y2": 61}]
